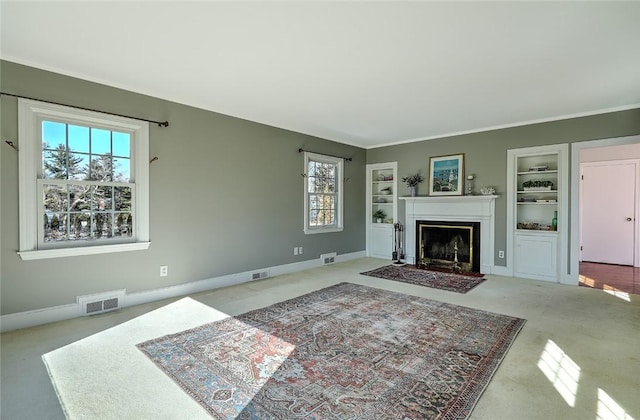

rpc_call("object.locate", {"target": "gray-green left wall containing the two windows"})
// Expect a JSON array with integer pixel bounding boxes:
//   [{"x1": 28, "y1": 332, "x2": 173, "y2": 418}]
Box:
[{"x1": 0, "y1": 61, "x2": 366, "y2": 315}]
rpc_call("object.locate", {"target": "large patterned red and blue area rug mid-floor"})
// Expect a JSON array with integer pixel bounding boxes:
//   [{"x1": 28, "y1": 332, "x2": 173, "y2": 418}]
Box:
[{"x1": 138, "y1": 283, "x2": 525, "y2": 420}]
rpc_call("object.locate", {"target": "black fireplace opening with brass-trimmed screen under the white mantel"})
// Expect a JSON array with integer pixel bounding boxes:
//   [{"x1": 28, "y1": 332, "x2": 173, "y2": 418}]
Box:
[{"x1": 415, "y1": 220, "x2": 480, "y2": 273}]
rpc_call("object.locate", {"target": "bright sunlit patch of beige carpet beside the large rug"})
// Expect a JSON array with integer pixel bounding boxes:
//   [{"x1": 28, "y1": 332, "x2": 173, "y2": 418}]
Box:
[{"x1": 42, "y1": 298, "x2": 222, "y2": 419}]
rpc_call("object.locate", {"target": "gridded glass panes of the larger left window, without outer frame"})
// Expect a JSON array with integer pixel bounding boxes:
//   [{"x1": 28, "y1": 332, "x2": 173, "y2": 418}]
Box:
[{"x1": 38, "y1": 120, "x2": 134, "y2": 243}]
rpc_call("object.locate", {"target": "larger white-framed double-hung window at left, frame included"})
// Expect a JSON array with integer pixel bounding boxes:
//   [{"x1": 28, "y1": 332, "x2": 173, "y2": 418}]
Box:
[{"x1": 18, "y1": 99, "x2": 149, "y2": 259}]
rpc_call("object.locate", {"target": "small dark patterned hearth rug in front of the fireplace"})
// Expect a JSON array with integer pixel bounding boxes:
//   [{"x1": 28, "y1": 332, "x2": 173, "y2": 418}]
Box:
[{"x1": 360, "y1": 265, "x2": 485, "y2": 293}]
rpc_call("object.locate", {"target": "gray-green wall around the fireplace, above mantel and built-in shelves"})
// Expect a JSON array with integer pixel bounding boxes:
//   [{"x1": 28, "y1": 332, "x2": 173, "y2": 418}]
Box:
[{"x1": 367, "y1": 109, "x2": 640, "y2": 266}]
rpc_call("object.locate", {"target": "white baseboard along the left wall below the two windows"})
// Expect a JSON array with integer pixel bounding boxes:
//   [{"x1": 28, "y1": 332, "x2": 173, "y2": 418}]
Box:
[{"x1": 0, "y1": 251, "x2": 366, "y2": 333}]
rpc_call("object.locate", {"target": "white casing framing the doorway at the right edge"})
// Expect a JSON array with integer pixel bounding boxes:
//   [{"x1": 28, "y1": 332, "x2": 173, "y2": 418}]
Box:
[{"x1": 568, "y1": 135, "x2": 640, "y2": 286}]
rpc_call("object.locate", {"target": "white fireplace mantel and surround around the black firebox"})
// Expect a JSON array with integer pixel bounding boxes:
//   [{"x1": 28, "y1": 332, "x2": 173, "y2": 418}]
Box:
[{"x1": 399, "y1": 195, "x2": 498, "y2": 274}]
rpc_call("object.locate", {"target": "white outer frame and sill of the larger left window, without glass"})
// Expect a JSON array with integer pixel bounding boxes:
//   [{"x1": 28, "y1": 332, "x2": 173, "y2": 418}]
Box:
[{"x1": 18, "y1": 98, "x2": 151, "y2": 260}]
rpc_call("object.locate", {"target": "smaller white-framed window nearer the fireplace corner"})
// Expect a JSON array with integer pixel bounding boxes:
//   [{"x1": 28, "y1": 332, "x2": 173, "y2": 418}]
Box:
[{"x1": 304, "y1": 152, "x2": 343, "y2": 233}]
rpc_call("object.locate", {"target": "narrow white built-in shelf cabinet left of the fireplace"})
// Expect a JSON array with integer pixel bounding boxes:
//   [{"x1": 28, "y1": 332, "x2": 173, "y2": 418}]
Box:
[{"x1": 366, "y1": 162, "x2": 398, "y2": 259}]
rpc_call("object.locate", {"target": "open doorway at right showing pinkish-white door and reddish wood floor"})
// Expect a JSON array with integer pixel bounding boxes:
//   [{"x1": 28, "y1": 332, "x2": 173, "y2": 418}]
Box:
[{"x1": 569, "y1": 136, "x2": 640, "y2": 293}]
